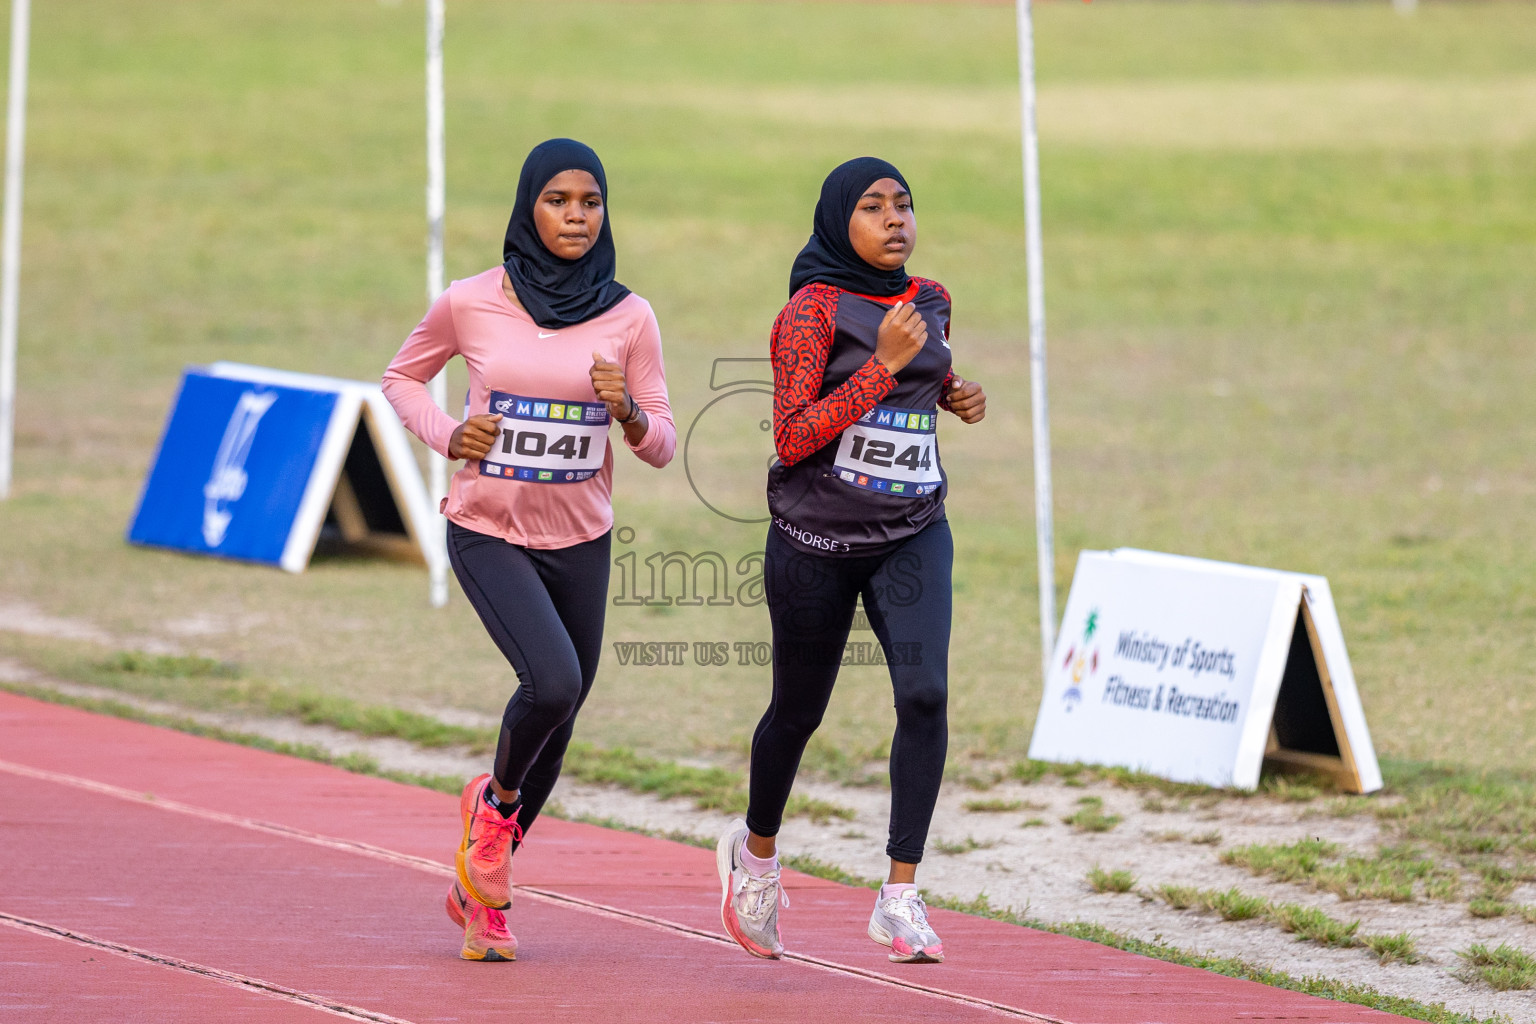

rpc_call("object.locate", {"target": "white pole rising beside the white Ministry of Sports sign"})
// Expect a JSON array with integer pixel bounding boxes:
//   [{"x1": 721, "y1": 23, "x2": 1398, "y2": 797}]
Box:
[{"x1": 1014, "y1": 0, "x2": 1055, "y2": 682}]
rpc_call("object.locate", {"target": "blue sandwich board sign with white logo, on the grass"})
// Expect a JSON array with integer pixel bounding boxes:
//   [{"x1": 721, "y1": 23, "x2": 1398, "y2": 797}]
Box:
[{"x1": 127, "y1": 362, "x2": 442, "y2": 573}]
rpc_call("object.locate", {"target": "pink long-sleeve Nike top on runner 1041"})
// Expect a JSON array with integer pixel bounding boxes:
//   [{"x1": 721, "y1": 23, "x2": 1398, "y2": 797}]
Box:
[{"x1": 384, "y1": 267, "x2": 677, "y2": 548}]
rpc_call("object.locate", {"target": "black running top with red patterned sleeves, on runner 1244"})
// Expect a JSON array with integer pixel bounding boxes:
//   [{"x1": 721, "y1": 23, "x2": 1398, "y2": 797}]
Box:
[{"x1": 768, "y1": 278, "x2": 954, "y2": 556}]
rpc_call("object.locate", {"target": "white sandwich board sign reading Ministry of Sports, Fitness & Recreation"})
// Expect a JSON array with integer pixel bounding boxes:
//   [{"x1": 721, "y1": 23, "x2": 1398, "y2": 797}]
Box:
[{"x1": 1029, "y1": 548, "x2": 1381, "y2": 792}]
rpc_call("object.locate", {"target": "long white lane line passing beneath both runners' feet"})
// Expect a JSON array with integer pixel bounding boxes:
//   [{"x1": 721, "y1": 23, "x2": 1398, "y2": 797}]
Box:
[{"x1": 0, "y1": 760, "x2": 1069, "y2": 1024}]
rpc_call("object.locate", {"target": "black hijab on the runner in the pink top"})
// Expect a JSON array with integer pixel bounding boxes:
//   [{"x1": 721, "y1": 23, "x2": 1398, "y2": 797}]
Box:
[{"x1": 501, "y1": 138, "x2": 630, "y2": 329}]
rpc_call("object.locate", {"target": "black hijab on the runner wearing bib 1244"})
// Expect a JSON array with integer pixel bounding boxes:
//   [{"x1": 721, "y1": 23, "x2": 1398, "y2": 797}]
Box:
[{"x1": 790, "y1": 157, "x2": 911, "y2": 296}]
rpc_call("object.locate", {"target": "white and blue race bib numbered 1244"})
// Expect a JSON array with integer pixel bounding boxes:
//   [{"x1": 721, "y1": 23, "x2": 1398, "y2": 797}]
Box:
[{"x1": 833, "y1": 405, "x2": 945, "y2": 497}]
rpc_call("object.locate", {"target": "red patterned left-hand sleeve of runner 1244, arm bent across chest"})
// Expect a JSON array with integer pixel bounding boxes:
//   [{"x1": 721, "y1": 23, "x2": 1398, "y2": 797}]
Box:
[{"x1": 770, "y1": 284, "x2": 895, "y2": 465}]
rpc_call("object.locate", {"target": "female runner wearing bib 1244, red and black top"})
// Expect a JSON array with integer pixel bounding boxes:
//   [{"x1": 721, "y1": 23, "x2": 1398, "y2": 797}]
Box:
[{"x1": 717, "y1": 157, "x2": 986, "y2": 963}]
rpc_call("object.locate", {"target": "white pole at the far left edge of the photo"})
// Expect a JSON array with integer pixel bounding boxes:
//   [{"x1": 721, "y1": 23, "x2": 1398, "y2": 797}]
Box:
[{"x1": 0, "y1": 0, "x2": 32, "y2": 499}]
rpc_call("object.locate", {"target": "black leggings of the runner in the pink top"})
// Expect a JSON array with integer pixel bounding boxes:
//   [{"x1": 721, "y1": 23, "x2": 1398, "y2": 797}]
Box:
[{"x1": 449, "y1": 522, "x2": 611, "y2": 829}]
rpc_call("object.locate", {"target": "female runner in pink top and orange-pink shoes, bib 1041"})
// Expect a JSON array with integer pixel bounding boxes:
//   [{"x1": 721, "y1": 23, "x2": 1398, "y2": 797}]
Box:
[{"x1": 384, "y1": 138, "x2": 677, "y2": 960}]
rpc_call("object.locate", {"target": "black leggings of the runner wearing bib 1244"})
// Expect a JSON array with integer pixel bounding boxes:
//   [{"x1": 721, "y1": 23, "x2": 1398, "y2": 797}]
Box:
[{"x1": 746, "y1": 519, "x2": 954, "y2": 864}]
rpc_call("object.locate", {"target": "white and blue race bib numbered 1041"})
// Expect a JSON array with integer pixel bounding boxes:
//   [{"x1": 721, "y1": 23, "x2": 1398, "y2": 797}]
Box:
[{"x1": 481, "y1": 391, "x2": 608, "y2": 484}]
